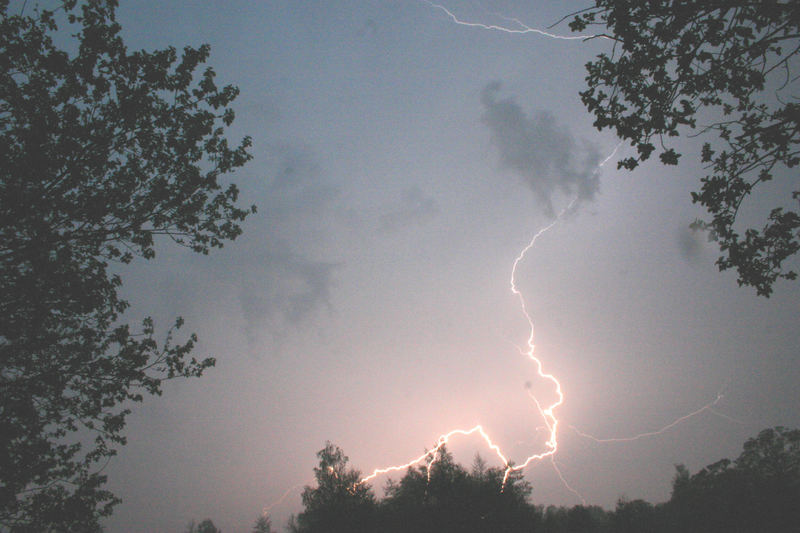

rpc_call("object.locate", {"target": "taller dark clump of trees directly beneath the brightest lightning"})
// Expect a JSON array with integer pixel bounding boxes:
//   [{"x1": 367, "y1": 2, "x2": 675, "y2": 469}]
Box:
[{"x1": 289, "y1": 443, "x2": 538, "y2": 533}]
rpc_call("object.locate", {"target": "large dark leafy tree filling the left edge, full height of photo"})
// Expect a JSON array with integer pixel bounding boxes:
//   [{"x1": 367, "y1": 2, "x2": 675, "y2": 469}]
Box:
[{"x1": 0, "y1": 0, "x2": 254, "y2": 531}]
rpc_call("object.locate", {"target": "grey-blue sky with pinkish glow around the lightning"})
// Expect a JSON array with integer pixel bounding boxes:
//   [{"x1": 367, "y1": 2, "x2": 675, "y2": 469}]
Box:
[{"x1": 100, "y1": 0, "x2": 800, "y2": 533}]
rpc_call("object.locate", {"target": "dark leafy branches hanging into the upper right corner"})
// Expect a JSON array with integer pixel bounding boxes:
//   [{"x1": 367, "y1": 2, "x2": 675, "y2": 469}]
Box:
[{"x1": 570, "y1": 0, "x2": 800, "y2": 296}]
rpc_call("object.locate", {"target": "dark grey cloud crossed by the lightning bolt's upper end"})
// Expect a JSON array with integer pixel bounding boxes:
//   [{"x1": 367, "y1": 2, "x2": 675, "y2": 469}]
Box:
[{"x1": 481, "y1": 82, "x2": 601, "y2": 216}]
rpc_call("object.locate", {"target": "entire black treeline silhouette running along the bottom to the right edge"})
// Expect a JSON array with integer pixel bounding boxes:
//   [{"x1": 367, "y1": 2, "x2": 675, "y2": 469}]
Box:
[{"x1": 287, "y1": 426, "x2": 800, "y2": 533}]
